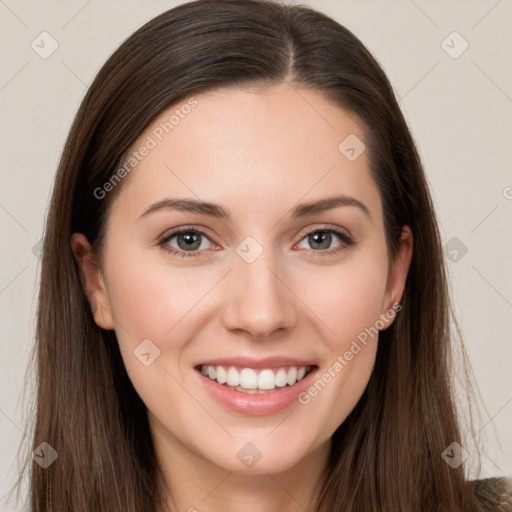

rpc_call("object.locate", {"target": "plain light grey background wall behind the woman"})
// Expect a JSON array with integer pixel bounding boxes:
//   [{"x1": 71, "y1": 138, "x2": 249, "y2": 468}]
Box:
[{"x1": 0, "y1": 0, "x2": 512, "y2": 510}]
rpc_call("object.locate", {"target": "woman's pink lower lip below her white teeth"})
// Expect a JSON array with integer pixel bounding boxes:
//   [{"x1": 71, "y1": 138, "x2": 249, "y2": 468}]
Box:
[{"x1": 196, "y1": 367, "x2": 318, "y2": 416}]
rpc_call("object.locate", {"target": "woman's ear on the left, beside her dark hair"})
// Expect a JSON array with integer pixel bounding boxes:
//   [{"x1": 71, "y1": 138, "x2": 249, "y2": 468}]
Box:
[{"x1": 71, "y1": 233, "x2": 114, "y2": 330}]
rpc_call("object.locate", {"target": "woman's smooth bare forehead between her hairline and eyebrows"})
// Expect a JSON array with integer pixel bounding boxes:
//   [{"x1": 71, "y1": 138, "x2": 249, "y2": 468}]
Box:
[{"x1": 109, "y1": 83, "x2": 380, "y2": 224}]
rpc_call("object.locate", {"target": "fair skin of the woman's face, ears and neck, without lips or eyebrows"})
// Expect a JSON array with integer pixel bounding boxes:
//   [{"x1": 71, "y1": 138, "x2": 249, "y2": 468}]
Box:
[{"x1": 72, "y1": 84, "x2": 413, "y2": 512}]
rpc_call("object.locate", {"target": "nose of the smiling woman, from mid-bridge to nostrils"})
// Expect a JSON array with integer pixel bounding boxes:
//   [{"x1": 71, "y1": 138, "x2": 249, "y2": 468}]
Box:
[{"x1": 222, "y1": 251, "x2": 299, "y2": 339}]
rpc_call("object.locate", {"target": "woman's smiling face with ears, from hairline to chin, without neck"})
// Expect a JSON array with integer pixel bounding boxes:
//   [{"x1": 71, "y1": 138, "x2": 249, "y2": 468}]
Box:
[{"x1": 73, "y1": 84, "x2": 412, "y2": 473}]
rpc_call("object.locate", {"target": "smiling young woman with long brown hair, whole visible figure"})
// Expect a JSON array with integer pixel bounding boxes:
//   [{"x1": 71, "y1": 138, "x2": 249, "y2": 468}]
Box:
[{"x1": 10, "y1": 0, "x2": 511, "y2": 512}]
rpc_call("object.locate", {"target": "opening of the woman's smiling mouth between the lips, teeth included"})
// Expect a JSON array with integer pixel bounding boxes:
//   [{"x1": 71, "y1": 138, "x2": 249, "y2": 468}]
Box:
[{"x1": 196, "y1": 364, "x2": 317, "y2": 395}]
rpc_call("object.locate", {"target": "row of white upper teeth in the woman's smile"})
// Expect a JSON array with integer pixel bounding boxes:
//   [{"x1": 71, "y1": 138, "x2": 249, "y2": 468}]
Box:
[{"x1": 201, "y1": 365, "x2": 310, "y2": 389}]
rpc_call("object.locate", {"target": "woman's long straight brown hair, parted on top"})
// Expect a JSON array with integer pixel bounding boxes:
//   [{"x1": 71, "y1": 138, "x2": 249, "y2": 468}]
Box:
[{"x1": 10, "y1": 0, "x2": 492, "y2": 512}]
